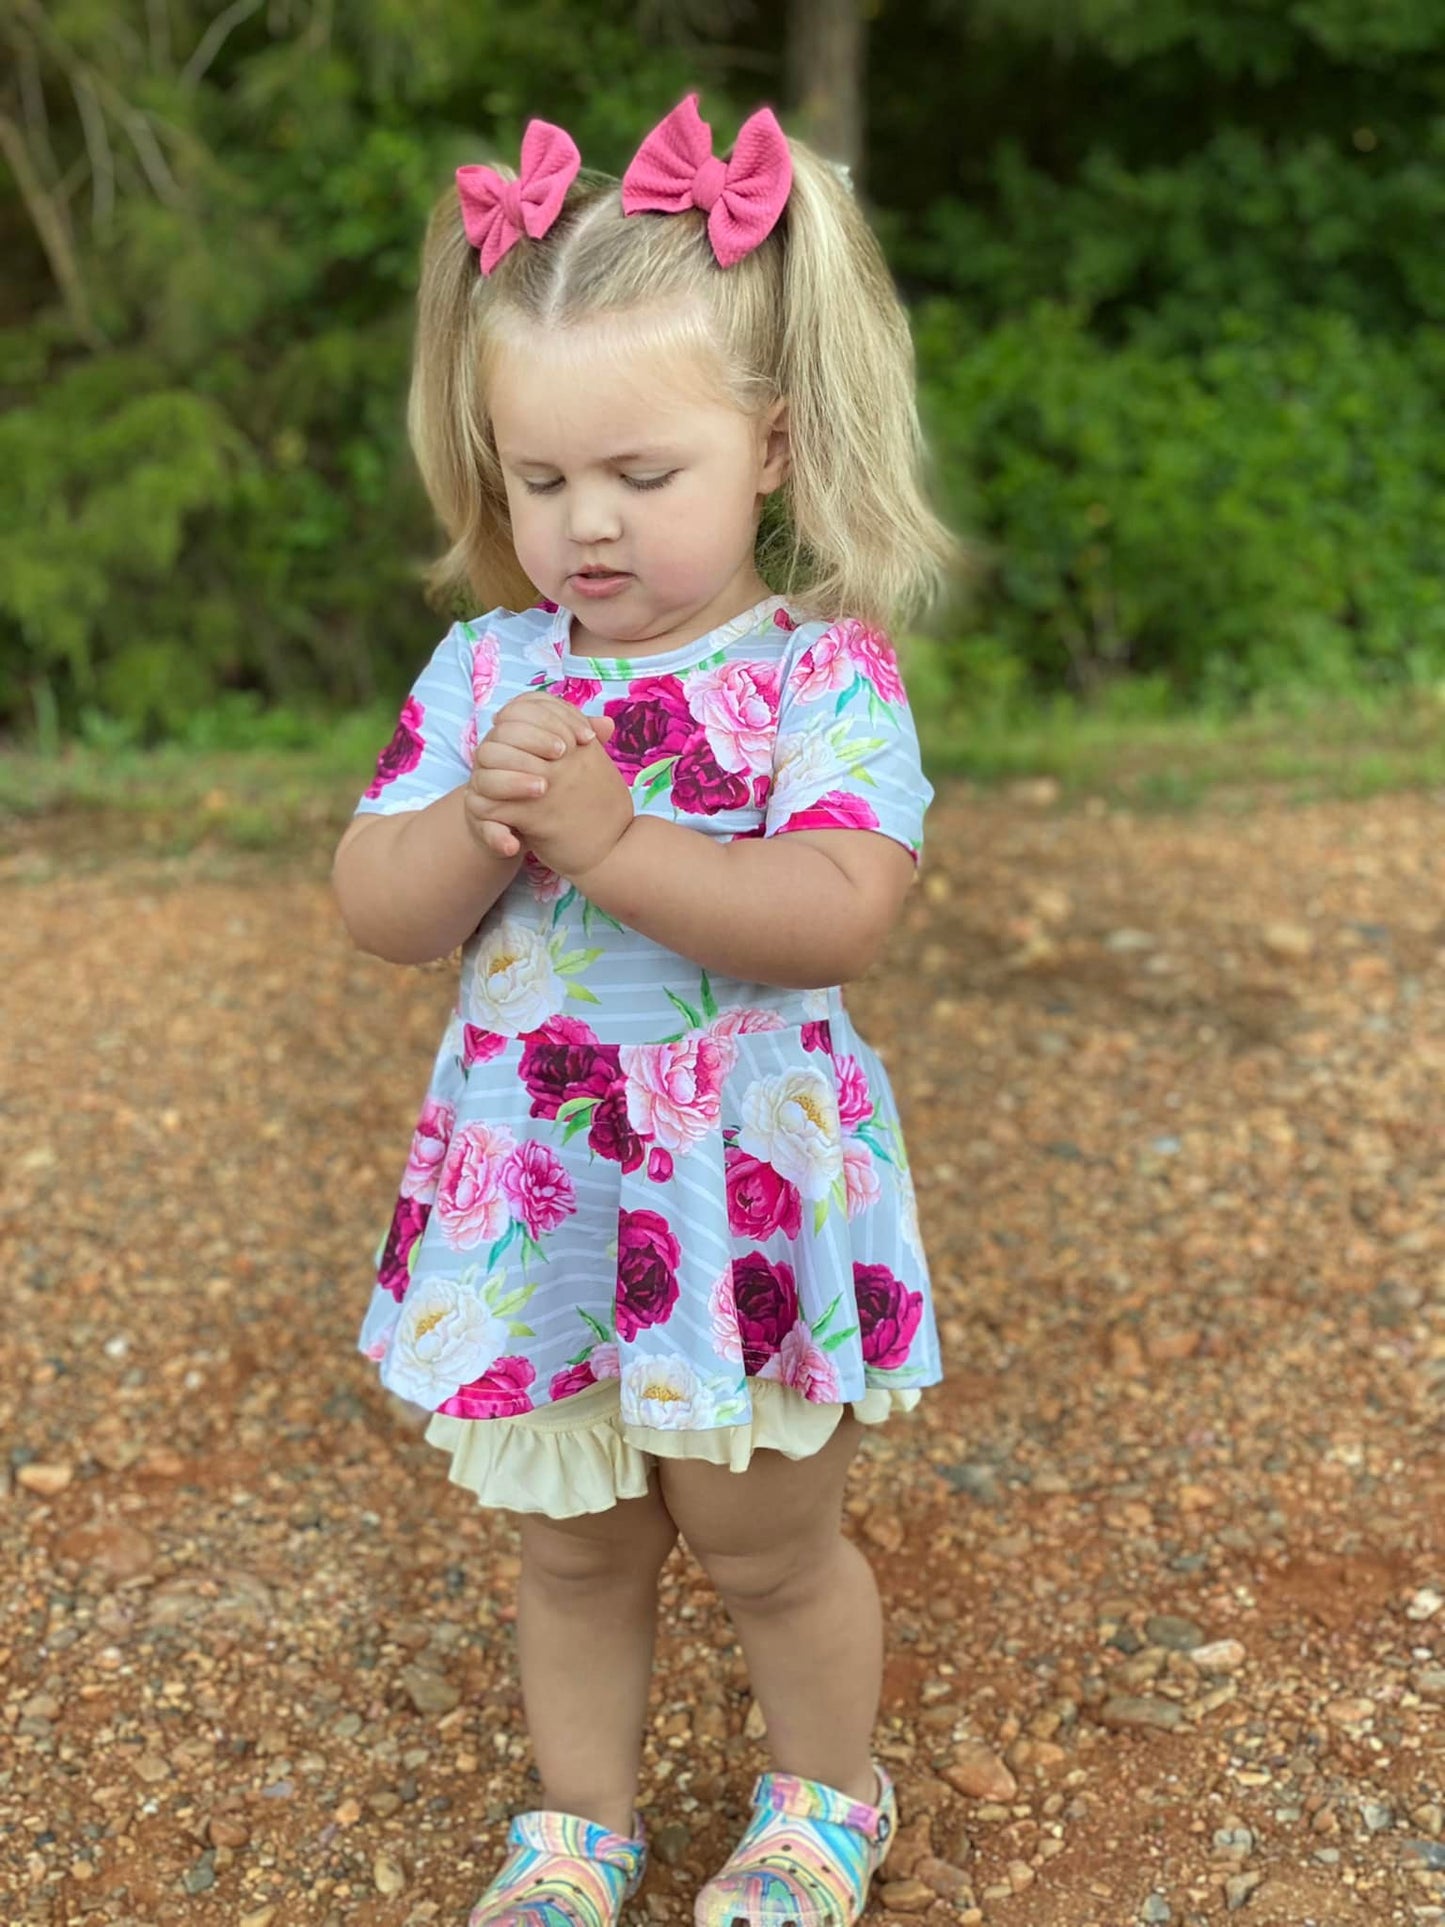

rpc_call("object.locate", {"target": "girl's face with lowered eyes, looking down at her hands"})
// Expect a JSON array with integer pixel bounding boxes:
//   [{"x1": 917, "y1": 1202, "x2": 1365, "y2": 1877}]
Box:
[{"x1": 487, "y1": 316, "x2": 786, "y2": 653}]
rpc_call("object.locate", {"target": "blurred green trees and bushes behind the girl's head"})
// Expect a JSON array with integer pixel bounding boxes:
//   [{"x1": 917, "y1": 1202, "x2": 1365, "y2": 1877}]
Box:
[{"x1": 0, "y1": 0, "x2": 1445, "y2": 744}]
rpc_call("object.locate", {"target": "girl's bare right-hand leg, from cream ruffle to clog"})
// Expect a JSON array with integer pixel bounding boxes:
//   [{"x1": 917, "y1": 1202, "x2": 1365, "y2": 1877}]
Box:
[{"x1": 659, "y1": 1412, "x2": 882, "y2": 1806}]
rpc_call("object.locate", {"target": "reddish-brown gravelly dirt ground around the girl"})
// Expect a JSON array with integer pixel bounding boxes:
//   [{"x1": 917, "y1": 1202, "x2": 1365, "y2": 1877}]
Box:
[{"x1": 0, "y1": 784, "x2": 1445, "y2": 1927}]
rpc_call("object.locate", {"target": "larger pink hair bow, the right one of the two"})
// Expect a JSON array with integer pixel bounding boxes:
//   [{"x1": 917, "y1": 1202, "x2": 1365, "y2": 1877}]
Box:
[{"x1": 622, "y1": 94, "x2": 792, "y2": 268}]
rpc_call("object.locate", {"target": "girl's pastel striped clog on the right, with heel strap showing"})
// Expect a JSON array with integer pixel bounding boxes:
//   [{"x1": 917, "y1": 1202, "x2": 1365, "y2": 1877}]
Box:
[{"x1": 696, "y1": 1767, "x2": 898, "y2": 1927}]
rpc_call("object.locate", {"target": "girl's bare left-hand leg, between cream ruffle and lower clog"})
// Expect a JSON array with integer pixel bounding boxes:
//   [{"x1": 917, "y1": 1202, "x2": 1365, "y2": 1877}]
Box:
[{"x1": 516, "y1": 1484, "x2": 676, "y2": 1835}]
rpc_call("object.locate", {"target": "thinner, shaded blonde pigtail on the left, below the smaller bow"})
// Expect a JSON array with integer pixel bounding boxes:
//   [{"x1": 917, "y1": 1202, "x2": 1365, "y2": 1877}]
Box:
[{"x1": 407, "y1": 182, "x2": 536, "y2": 609}]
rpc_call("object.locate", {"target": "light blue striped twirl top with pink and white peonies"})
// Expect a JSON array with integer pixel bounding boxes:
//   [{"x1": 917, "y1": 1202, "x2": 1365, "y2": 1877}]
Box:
[{"x1": 346, "y1": 597, "x2": 940, "y2": 1430}]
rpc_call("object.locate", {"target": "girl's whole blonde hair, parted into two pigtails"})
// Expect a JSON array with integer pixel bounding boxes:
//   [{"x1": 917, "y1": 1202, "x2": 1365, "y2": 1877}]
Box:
[{"x1": 407, "y1": 122, "x2": 961, "y2": 626}]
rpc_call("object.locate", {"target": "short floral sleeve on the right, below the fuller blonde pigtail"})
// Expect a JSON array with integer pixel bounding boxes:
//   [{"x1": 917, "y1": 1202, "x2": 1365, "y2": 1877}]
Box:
[{"x1": 763, "y1": 619, "x2": 934, "y2": 863}]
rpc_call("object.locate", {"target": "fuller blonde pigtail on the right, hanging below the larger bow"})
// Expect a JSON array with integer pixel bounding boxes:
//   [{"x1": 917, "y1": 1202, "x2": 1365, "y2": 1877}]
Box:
[{"x1": 778, "y1": 141, "x2": 963, "y2": 626}]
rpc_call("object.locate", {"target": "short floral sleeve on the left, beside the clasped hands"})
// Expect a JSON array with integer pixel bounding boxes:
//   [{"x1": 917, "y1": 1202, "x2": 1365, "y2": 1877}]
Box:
[{"x1": 353, "y1": 622, "x2": 497, "y2": 815}]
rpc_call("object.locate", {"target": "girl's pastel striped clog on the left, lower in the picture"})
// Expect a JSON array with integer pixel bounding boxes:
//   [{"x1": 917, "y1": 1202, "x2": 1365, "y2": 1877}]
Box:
[{"x1": 466, "y1": 1811, "x2": 647, "y2": 1927}]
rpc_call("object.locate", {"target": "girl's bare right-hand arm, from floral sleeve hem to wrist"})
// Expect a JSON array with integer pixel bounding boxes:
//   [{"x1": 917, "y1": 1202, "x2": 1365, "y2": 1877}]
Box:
[{"x1": 568, "y1": 815, "x2": 915, "y2": 990}]
